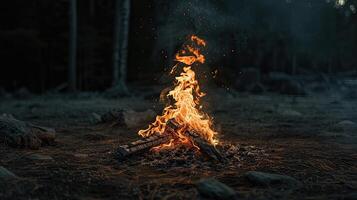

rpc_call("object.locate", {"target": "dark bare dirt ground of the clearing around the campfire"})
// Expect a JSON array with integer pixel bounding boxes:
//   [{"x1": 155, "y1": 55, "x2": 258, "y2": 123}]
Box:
[{"x1": 0, "y1": 89, "x2": 357, "y2": 199}]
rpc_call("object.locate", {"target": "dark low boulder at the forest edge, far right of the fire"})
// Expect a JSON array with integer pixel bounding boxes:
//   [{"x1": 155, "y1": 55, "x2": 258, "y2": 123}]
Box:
[{"x1": 265, "y1": 72, "x2": 307, "y2": 95}]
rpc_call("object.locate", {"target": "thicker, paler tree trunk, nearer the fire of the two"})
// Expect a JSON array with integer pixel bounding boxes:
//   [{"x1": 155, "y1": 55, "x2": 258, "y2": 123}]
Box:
[{"x1": 112, "y1": 0, "x2": 130, "y2": 94}]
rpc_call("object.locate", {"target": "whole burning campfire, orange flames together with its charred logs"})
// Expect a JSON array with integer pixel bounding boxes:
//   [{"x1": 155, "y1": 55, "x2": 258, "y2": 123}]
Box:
[{"x1": 118, "y1": 35, "x2": 222, "y2": 160}]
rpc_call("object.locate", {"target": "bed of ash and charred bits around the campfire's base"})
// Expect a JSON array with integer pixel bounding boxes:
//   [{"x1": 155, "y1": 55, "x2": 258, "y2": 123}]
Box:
[{"x1": 139, "y1": 144, "x2": 268, "y2": 171}]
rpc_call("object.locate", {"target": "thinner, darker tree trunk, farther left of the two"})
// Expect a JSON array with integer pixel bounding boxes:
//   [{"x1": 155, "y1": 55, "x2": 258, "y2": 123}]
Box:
[{"x1": 68, "y1": 0, "x2": 77, "y2": 92}]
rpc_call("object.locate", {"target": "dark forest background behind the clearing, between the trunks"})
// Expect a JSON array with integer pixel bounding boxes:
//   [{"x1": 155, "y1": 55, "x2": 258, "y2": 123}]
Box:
[{"x1": 0, "y1": 0, "x2": 357, "y2": 93}]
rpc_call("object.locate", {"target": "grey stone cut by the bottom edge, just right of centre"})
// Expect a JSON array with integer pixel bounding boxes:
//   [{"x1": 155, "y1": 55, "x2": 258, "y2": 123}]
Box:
[{"x1": 196, "y1": 178, "x2": 236, "y2": 199}]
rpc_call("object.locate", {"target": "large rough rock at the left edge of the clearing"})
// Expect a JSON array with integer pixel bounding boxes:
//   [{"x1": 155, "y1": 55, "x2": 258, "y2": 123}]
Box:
[{"x1": 0, "y1": 114, "x2": 56, "y2": 149}]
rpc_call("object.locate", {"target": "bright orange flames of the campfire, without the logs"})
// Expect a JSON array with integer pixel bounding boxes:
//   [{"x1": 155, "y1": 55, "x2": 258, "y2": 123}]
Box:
[{"x1": 139, "y1": 35, "x2": 218, "y2": 151}]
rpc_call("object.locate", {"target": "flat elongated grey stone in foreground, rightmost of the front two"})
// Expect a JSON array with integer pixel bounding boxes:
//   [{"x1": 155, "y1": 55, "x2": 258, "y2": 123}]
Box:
[{"x1": 244, "y1": 171, "x2": 301, "y2": 187}]
